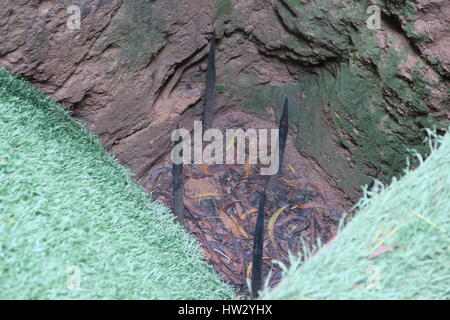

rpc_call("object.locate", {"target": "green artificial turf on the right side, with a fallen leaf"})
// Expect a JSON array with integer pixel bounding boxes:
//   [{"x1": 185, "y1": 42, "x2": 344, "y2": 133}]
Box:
[{"x1": 262, "y1": 131, "x2": 450, "y2": 299}]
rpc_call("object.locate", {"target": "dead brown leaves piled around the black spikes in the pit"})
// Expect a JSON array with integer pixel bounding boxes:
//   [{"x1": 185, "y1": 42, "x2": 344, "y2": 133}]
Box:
[{"x1": 146, "y1": 163, "x2": 339, "y2": 295}]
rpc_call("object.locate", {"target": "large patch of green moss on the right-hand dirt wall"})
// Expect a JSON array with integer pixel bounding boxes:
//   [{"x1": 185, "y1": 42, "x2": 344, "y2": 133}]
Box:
[{"x1": 216, "y1": 0, "x2": 448, "y2": 198}]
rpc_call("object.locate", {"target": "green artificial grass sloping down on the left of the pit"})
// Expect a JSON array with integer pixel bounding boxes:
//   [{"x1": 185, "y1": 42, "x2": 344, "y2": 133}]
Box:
[{"x1": 0, "y1": 68, "x2": 235, "y2": 299}]
